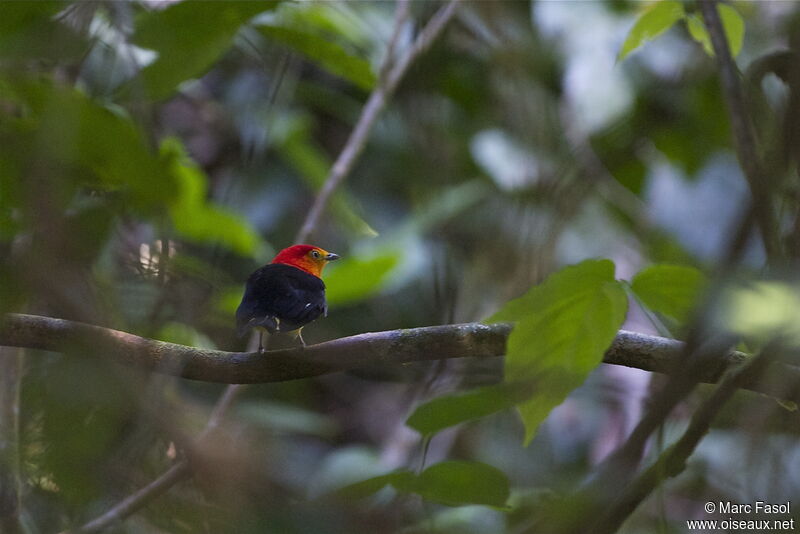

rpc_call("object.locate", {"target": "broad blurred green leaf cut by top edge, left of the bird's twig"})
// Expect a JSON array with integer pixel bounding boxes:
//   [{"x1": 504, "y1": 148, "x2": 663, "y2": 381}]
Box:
[{"x1": 133, "y1": 0, "x2": 279, "y2": 99}]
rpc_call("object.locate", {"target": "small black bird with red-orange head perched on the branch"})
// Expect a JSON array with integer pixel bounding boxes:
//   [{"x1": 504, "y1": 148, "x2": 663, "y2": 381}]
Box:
[{"x1": 236, "y1": 245, "x2": 339, "y2": 352}]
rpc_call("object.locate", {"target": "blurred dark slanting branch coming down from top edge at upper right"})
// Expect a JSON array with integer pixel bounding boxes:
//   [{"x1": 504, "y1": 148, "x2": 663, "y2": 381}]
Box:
[{"x1": 697, "y1": 0, "x2": 780, "y2": 258}]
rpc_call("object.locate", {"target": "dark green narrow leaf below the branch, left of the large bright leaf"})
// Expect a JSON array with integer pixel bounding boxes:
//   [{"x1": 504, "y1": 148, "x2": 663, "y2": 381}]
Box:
[{"x1": 406, "y1": 382, "x2": 533, "y2": 436}]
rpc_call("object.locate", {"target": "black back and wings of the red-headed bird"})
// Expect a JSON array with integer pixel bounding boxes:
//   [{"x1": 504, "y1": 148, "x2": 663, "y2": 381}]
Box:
[{"x1": 236, "y1": 264, "x2": 327, "y2": 336}]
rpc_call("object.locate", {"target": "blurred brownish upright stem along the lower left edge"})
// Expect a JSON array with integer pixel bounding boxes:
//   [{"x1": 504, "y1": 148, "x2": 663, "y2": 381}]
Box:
[{"x1": 0, "y1": 347, "x2": 23, "y2": 534}]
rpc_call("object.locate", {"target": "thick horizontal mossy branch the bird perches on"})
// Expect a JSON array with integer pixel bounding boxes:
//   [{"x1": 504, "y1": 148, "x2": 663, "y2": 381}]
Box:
[{"x1": 0, "y1": 314, "x2": 800, "y2": 401}]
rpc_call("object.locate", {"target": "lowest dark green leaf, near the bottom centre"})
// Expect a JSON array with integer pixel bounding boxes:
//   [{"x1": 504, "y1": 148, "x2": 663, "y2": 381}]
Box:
[{"x1": 335, "y1": 461, "x2": 510, "y2": 507}]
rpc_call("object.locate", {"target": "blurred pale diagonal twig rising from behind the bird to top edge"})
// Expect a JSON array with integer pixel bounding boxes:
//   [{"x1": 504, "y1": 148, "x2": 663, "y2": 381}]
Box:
[{"x1": 295, "y1": 0, "x2": 458, "y2": 243}]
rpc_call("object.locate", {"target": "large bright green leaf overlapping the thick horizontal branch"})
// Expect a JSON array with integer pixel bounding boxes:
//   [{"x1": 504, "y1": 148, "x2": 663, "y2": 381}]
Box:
[{"x1": 485, "y1": 260, "x2": 628, "y2": 444}]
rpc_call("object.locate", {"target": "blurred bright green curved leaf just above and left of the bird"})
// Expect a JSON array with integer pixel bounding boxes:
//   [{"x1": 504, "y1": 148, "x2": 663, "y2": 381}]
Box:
[{"x1": 162, "y1": 138, "x2": 260, "y2": 256}]
